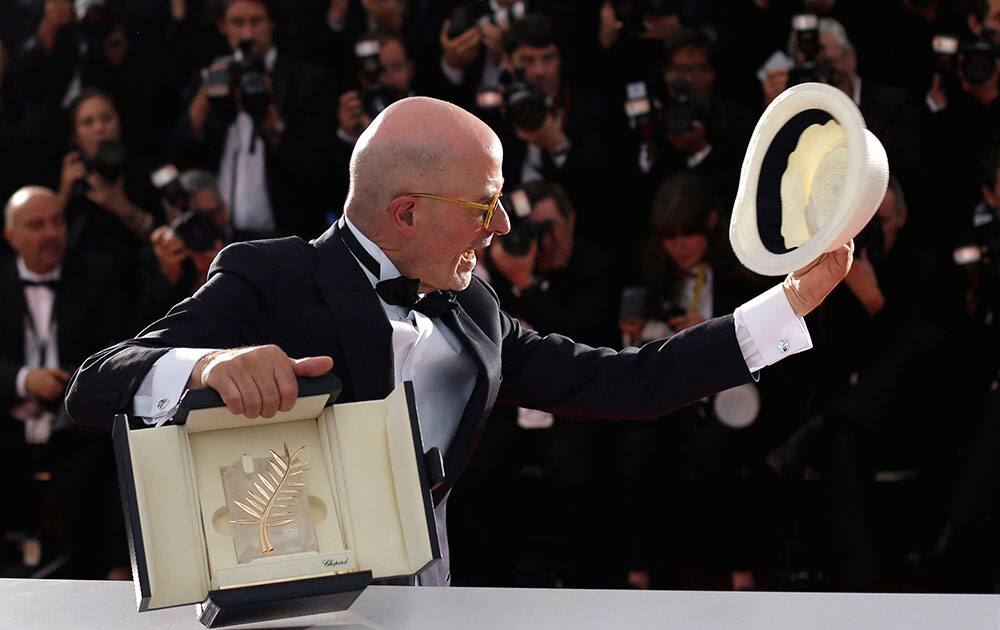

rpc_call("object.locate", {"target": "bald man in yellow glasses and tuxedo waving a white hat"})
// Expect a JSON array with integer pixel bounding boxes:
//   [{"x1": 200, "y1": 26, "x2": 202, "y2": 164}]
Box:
[{"x1": 67, "y1": 97, "x2": 850, "y2": 585}]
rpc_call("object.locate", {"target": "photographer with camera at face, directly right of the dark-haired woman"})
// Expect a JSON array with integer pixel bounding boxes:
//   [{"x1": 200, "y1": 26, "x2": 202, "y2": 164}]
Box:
[{"x1": 136, "y1": 167, "x2": 231, "y2": 330}]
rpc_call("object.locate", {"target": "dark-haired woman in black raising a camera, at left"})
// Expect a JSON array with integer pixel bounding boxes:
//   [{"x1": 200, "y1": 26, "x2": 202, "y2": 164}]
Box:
[{"x1": 58, "y1": 88, "x2": 160, "y2": 270}]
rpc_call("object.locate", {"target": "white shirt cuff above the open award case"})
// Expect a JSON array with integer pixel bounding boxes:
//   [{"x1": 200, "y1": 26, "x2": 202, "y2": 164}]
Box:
[{"x1": 132, "y1": 348, "x2": 215, "y2": 425}]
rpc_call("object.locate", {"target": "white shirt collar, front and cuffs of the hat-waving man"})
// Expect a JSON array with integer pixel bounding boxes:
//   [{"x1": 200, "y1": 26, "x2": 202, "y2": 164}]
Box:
[{"x1": 133, "y1": 226, "x2": 812, "y2": 444}]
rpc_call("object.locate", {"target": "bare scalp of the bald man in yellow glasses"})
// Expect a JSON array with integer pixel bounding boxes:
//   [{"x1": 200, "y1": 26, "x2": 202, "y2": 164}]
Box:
[{"x1": 345, "y1": 97, "x2": 502, "y2": 228}]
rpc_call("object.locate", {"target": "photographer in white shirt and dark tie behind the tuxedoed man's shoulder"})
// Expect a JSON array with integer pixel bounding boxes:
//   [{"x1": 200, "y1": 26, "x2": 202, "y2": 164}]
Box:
[{"x1": 171, "y1": 0, "x2": 334, "y2": 240}]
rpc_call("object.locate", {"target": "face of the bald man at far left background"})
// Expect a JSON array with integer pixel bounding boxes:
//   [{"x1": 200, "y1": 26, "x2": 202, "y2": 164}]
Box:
[{"x1": 4, "y1": 192, "x2": 66, "y2": 274}]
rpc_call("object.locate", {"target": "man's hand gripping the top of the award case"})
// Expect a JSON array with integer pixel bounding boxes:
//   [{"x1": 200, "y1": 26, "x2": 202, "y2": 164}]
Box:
[{"x1": 187, "y1": 344, "x2": 333, "y2": 419}]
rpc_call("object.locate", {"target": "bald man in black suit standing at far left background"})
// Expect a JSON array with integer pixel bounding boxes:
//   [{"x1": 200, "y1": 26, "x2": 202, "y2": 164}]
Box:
[{"x1": 0, "y1": 186, "x2": 128, "y2": 579}]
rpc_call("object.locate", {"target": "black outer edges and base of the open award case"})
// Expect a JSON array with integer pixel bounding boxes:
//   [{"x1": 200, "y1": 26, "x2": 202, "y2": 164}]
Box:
[{"x1": 113, "y1": 374, "x2": 444, "y2": 628}]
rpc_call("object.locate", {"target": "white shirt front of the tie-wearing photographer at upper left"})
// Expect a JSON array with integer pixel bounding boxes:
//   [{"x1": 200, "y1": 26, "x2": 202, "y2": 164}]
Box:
[{"x1": 219, "y1": 48, "x2": 278, "y2": 232}]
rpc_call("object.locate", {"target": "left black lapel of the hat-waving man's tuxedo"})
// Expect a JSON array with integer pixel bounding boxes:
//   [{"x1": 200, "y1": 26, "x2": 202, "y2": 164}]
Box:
[{"x1": 315, "y1": 226, "x2": 394, "y2": 400}]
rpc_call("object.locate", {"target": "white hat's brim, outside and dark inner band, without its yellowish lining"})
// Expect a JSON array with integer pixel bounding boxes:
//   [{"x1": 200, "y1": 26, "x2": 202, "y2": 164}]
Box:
[{"x1": 729, "y1": 83, "x2": 889, "y2": 276}]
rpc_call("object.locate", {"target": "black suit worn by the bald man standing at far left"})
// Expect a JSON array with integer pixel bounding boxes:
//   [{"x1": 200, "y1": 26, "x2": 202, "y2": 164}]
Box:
[{"x1": 0, "y1": 254, "x2": 128, "y2": 579}]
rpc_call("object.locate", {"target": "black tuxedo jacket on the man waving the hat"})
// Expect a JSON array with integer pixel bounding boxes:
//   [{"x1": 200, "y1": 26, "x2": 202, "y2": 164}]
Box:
[{"x1": 67, "y1": 226, "x2": 750, "y2": 500}]
